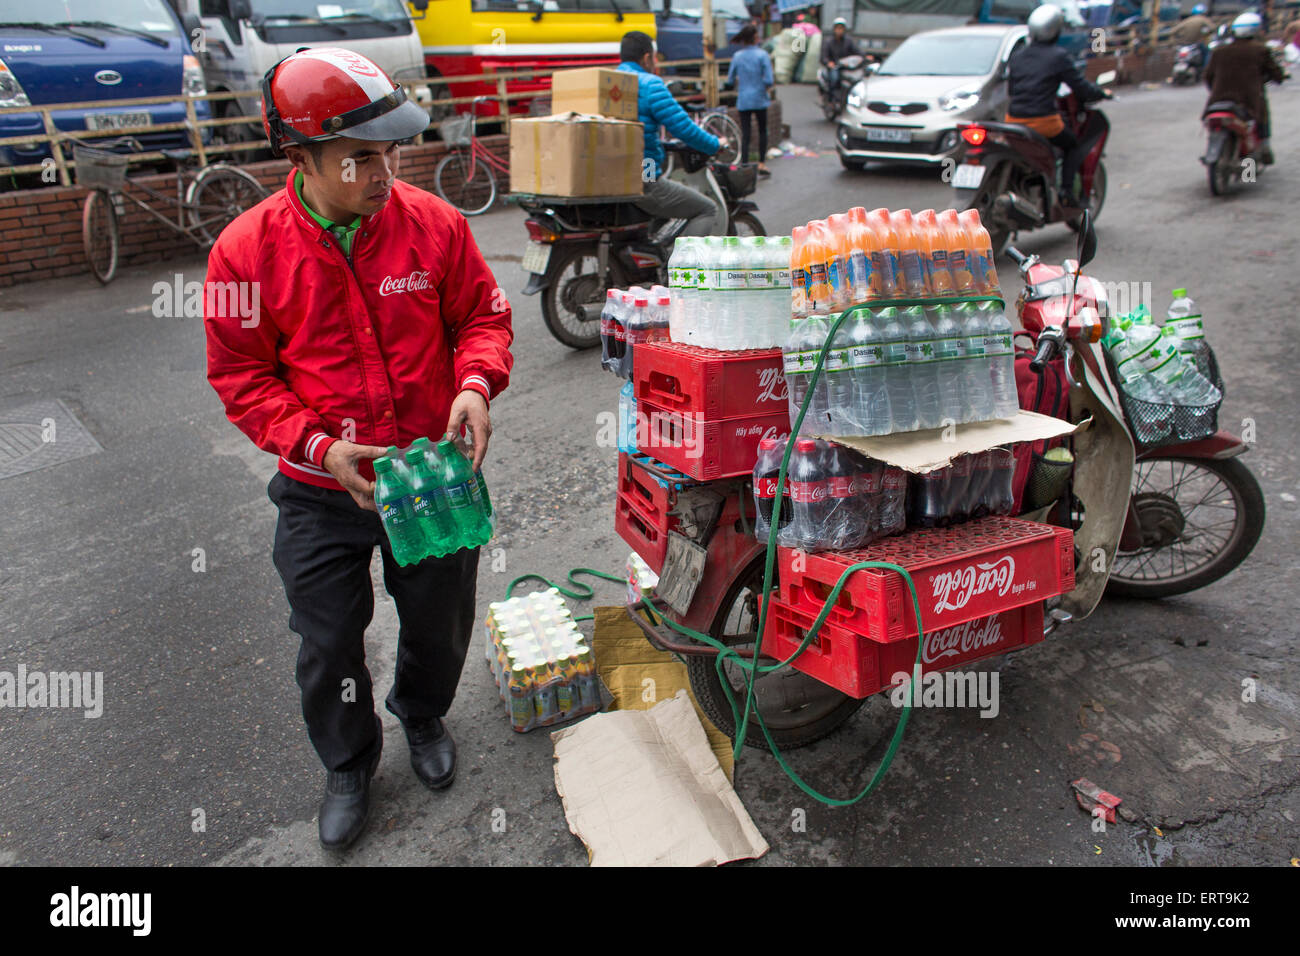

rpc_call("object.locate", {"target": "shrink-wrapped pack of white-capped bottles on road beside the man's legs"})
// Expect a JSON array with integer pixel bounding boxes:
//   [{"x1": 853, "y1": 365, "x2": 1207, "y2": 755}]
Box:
[{"x1": 485, "y1": 588, "x2": 601, "y2": 734}]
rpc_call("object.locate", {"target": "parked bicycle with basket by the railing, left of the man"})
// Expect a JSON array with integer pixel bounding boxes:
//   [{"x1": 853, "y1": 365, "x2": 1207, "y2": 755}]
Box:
[{"x1": 73, "y1": 137, "x2": 270, "y2": 285}]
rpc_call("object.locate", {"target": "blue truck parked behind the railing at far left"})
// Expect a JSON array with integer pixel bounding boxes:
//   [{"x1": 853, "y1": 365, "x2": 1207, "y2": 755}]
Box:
[{"x1": 0, "y1": 0, "x2": 211, "y2": 178}]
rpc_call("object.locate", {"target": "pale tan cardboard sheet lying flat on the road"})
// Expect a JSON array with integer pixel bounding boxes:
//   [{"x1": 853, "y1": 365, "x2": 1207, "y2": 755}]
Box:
[{"x1": 551, "y1": 689, "x2": 768, "y2": 866}]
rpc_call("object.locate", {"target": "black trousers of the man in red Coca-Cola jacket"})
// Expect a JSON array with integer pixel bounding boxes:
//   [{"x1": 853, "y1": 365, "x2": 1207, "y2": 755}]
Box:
[{"x1": 267, "y1": 472, "x2": 478, "y2": 770}]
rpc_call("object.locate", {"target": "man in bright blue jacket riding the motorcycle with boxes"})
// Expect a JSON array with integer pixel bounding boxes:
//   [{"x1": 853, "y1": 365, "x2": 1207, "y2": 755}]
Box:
[{"x1": 619, "y1": 30, "x2": 722, "y2": 235}]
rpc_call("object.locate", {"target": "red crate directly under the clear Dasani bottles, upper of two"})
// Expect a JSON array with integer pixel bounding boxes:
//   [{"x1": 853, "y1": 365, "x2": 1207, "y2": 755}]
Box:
[{"x1": 632, "y1": 342, "x2": 788, "y2": 420}]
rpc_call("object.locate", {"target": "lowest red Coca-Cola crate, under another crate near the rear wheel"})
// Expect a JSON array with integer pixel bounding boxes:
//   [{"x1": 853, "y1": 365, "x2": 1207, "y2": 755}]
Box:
[{"x1": 763, "y1": 597, "x2": 1043, "y2": 697}]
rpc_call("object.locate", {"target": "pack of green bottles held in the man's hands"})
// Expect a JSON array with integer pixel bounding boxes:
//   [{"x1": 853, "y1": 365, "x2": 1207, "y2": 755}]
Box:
[{"x1": 374, "y1": 438, "x2": 493, "y2": 567}]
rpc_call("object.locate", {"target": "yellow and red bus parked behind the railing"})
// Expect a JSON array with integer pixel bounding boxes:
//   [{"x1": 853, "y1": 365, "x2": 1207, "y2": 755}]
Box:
[{"x1": 408, "y1": 0, "x2": 655, "y2": 114}]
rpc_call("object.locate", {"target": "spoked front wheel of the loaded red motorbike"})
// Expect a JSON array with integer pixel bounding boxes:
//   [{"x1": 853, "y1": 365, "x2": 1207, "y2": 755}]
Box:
[{"x1": 1106, "y1": 458, "x2": 1265, "y2": 598}]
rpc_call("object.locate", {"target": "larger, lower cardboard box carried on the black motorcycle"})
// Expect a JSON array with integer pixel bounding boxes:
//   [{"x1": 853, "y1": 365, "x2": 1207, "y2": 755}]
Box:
[{"x1": 510, "y1": 113, "x2": 645, "y2": 196}]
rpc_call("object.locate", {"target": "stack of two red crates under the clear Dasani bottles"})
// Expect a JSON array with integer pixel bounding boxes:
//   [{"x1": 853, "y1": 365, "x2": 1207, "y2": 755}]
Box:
[{"x1": 633, "y1": 342, "x2": 790, "y2": 481}]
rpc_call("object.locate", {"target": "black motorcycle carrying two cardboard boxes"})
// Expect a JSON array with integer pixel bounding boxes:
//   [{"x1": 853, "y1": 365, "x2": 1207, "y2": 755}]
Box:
[{"x1": 511, "y1": 140, "x2": 767, "y2": 349}]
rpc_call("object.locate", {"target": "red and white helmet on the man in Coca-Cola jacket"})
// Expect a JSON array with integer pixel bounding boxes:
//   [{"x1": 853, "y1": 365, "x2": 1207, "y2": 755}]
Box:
[{"x1": 261, "y1": 47, "x2": 429, "y2": 156}]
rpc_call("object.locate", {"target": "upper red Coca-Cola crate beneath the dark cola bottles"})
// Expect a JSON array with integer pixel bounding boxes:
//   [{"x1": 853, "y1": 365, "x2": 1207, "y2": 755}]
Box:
[{"x1": 779, "y1": 516, "x2": 1074, "y2": 643}]
